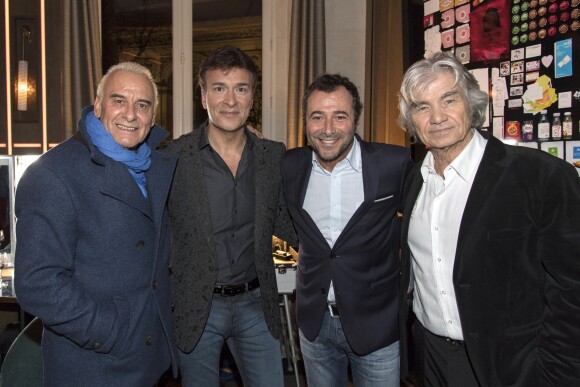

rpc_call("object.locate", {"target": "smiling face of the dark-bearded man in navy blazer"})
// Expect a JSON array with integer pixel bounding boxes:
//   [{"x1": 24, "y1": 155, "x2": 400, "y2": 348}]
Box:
[{"x1": 306, "y1": 86, "x2": 355, "y2": 171}]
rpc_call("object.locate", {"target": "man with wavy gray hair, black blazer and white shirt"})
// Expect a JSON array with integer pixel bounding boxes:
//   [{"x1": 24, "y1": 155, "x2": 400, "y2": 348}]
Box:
[{"x1": 399, "y1": 53, "x2": 580, "y2": 387}]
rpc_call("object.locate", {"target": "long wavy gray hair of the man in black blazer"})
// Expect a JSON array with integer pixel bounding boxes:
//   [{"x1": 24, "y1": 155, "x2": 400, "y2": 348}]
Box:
[{"x1": 398, "y1": 52, "x2": 489, "y2": 136}]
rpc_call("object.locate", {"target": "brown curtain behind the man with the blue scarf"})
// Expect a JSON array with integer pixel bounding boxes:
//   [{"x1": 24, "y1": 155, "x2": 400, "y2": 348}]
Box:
[{"x1": 62, "y1": 0, "x2": 103, "y2": 139}]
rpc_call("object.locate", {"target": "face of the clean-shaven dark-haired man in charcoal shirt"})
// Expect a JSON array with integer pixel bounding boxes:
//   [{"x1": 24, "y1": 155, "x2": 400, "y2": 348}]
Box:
[{"x1": 201, "y1": 68, "x2": 254, "y2": 136}]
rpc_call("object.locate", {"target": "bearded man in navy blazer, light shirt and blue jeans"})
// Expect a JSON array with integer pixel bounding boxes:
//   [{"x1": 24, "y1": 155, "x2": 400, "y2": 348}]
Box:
[{"x1": 281, "y1": 74, "x2": 412, "y2": 387}]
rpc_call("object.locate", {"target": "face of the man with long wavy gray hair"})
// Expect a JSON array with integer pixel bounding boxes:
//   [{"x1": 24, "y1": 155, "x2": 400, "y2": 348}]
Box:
[{"x1": 411, "y1": 71, "x2": 473, "y2": 160}]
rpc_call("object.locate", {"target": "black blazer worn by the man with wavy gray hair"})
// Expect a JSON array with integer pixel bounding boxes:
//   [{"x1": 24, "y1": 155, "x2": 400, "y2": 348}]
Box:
[{"x1": 401, "y1": 134, "x2": 580, "y2": 387}]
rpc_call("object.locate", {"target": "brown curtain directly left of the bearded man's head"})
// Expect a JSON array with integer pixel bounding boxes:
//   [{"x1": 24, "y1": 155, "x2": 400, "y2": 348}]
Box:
[{"x1": 287, "y1": 0, "x2": 326, "y2": 149}]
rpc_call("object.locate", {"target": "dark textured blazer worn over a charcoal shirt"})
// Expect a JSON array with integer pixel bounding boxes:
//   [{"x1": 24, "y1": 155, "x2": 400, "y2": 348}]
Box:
[{"x1": 167, "y1": 123, "x2": 296, "y2": 353}]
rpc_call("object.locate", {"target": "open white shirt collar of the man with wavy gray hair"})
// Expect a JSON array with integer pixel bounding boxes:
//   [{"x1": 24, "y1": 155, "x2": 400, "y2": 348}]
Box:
[{"x1": 421, "y1": 129, "x2": 487, "y2": 182}]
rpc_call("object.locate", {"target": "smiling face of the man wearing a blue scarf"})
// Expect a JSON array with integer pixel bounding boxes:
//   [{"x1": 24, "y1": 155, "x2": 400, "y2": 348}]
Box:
[{"x1": 95, "y1": 70, "x2": 155, "y2": 149}]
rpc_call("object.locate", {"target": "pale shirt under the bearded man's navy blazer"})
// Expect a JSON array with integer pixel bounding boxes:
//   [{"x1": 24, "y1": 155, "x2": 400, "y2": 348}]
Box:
[{"x1": 303, "y1": 137, "x2": 364, "y2": 302}]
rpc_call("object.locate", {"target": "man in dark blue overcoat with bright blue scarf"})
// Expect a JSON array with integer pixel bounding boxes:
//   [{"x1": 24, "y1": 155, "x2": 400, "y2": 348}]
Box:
[{"x1": 15, "y1": 62, "x2": 177, "y2": 387}]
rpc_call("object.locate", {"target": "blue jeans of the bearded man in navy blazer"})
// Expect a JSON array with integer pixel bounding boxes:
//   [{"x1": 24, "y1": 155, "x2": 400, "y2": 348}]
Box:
[{"x1": 300, "y1": 311, "x2": 400, "y2": 387}]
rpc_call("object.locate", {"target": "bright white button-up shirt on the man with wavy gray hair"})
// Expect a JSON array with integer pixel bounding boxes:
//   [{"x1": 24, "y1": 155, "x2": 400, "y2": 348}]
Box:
[{"x1": 408, "y1": 130, "x2": 487, "y2": 340}]
